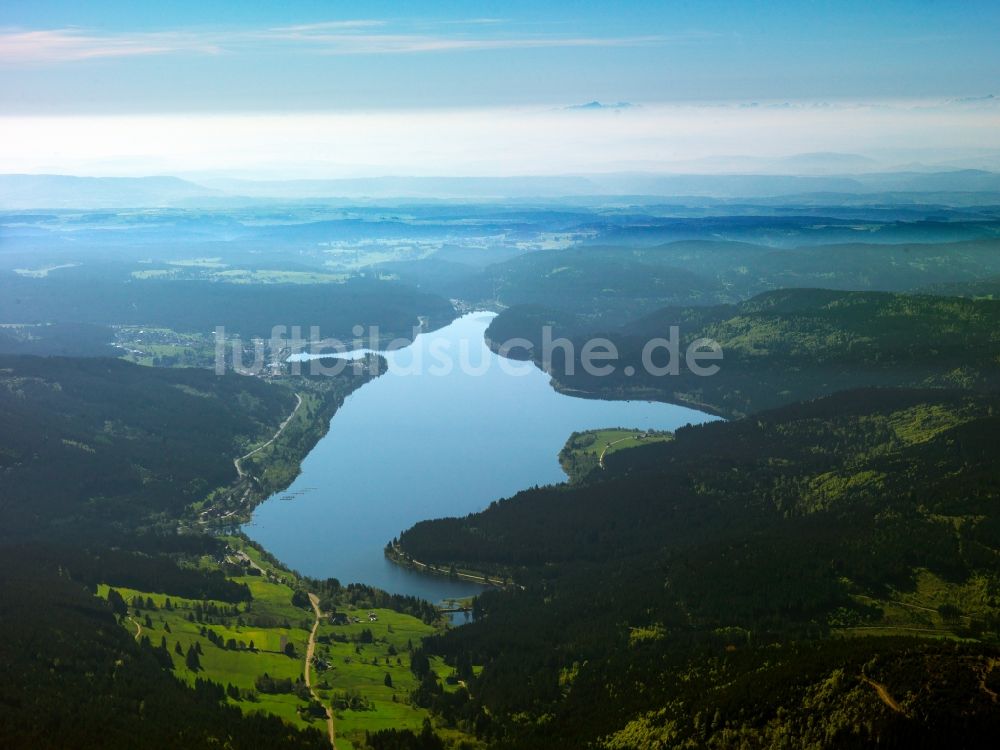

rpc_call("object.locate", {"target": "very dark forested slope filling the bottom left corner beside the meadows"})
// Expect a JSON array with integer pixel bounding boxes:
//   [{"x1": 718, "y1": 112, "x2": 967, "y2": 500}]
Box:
[{"x1": 0, "y1": 546, "x2": 329, "y2": 750}]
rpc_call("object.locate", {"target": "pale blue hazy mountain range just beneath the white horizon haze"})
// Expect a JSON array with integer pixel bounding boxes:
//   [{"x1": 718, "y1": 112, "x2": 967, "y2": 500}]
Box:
[{"x1": 0, "y1": 168, "x2": 1000, "y2": 210}]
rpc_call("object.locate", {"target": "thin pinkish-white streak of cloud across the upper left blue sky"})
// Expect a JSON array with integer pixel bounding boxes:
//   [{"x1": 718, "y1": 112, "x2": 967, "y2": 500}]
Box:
[{"x1": 0, "y1": 19, "x2": 680, "y2": 65}]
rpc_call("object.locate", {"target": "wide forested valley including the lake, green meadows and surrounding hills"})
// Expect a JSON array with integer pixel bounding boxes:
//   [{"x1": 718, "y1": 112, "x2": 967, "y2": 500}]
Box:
[{"x1": 0, "y1": 197, "x2": 1000, "y2": 750}]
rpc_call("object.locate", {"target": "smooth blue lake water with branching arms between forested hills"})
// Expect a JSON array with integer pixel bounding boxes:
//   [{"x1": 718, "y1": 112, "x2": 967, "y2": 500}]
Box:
[{"x1": 244, "y1": 313, "x2": 714, "y2": 602}]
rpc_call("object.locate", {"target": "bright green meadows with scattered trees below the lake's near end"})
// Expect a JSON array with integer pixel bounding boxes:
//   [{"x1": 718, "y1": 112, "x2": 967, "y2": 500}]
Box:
[{"x1": 97, "y1": 537, "x2": 469, "y2": 750}]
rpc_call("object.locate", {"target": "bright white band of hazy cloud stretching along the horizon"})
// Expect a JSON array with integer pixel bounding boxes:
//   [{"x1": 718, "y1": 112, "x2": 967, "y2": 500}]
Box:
[{"x1": 0, "y1": 102, "x2": 1000, "y2": 178}]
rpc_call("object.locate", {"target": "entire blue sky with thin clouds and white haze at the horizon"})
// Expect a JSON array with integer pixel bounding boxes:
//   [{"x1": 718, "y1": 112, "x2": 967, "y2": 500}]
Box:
[{"x1": 0, "y1": 0, "x2": 1000, "y2": 177}]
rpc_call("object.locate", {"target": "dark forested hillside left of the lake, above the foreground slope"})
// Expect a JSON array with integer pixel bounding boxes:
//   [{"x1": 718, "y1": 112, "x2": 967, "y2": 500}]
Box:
[{"x1": 0, "y1": 356, "x2": 296, "y2": 540}]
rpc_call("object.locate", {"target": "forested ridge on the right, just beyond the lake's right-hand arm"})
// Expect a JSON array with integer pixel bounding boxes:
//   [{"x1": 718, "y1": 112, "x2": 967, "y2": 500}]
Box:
[{"x1": 487, "y1": 289, "x2": 1000, "y2": 416}]
